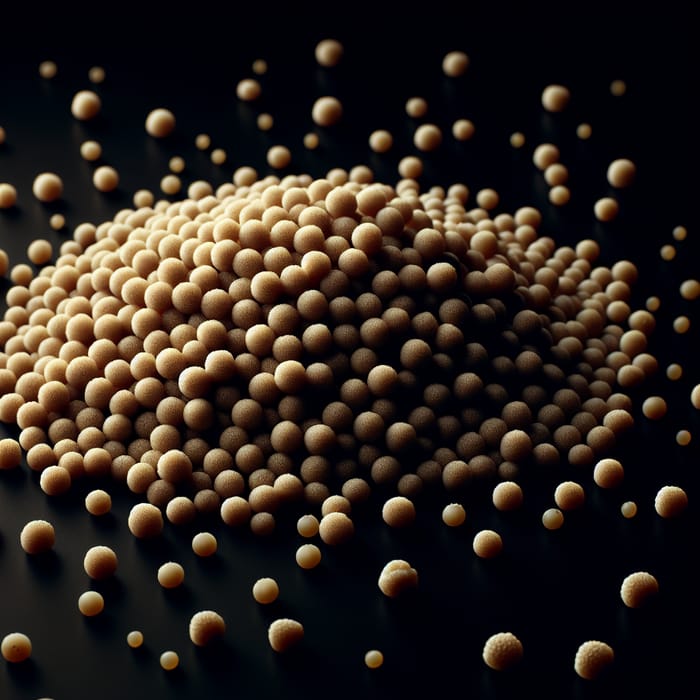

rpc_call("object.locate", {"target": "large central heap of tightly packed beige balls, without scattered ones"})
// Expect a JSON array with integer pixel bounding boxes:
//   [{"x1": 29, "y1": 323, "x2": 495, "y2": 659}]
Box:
[{"x1": 0, "y1": 169, "x2": 653, "y2": 541}]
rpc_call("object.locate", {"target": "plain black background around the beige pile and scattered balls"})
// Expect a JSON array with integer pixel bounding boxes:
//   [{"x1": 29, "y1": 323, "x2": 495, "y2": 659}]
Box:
[{"x1": 0, "y1": 3, "x2": 700, "y2": 700}]
